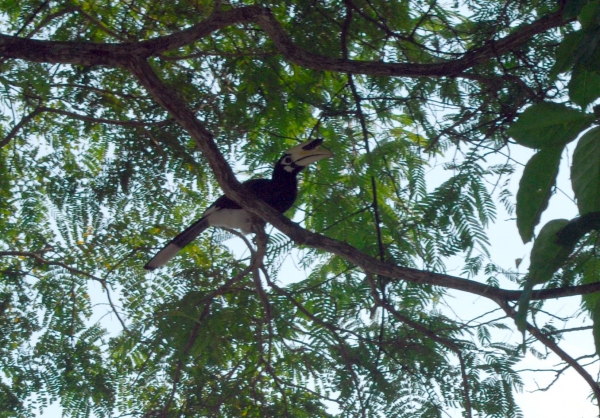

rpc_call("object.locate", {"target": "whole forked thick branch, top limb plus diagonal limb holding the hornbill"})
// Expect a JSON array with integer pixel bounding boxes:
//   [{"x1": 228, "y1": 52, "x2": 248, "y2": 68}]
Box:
[{"x1": 0, "y1": 6, "x2": 576, "y2": 301}]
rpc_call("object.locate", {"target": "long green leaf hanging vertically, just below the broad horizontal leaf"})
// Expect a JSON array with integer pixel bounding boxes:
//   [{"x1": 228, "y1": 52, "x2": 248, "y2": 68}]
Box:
[{"x1": 517, "y1": 147, "x2": 563, "y2": 243}]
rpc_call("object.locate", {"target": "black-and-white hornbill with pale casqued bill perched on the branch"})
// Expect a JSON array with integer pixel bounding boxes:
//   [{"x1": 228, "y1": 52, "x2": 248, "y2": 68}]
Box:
[{"x1": 144, "y1": 138, "x2": 333, "y2": 270}]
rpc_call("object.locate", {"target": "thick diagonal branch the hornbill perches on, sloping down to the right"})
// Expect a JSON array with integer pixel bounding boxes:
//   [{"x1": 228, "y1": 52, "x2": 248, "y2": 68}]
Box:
[{"x1": 124, "y1": 55, "x2": 600, "y2": 303}]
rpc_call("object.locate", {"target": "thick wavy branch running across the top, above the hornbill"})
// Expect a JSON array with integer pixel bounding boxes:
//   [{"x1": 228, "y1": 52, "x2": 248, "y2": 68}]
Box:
[{"x1": 0, "y1": 6, "x2": 568, "y2": 77}]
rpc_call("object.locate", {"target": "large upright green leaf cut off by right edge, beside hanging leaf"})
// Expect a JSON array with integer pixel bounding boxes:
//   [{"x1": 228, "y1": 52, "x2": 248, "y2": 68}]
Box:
[{"x1": 571, "y1": 127, "x2": 600, "y2": 215}]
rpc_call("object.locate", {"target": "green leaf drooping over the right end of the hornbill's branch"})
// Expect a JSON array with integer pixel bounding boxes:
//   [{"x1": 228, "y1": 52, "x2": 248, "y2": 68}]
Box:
[{"x1": 515, "y1": 219, "x2": 573, "y2": 332}]
